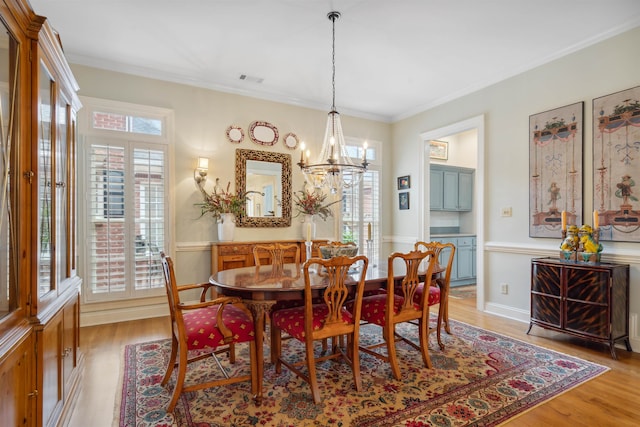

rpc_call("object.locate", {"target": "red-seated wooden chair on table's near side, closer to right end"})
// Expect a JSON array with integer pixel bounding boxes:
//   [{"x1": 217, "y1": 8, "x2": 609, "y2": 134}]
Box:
[{"x1": 360, "y1": 251, "x2": 437, "y2": 380}]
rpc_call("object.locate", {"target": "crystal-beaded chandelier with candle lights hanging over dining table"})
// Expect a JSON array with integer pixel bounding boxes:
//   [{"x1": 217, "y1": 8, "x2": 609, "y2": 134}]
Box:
[{"x1": 298, "y1": 12, "x2": 369, "y2": 194}]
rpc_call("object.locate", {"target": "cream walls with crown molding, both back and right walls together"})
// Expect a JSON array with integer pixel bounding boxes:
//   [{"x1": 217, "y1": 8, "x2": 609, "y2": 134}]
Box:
[{"x1": 72, "y1": 28, "x2": 640, "y2": 349}]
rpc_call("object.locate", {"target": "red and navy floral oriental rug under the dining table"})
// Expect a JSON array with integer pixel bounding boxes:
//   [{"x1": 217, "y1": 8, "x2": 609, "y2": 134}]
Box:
[{"x1": 114, "y1": 320, "x2": 608, "y2": 427}]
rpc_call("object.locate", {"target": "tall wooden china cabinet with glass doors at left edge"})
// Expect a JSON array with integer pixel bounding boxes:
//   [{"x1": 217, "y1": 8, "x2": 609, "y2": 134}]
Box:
[{"x1": 0, "y1": 0, "x2": 83, "y2": 426}]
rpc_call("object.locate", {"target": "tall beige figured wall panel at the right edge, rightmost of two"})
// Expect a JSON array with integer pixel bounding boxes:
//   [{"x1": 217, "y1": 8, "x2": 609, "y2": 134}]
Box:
[{"x1": 593, "y1": 86, "x2": 640, "y2": 242}]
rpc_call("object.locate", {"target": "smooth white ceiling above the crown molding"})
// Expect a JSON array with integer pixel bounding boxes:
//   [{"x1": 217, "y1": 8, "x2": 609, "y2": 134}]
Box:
[{"x1": 30, "y1": 0, "x2": 640, "y2": 121}]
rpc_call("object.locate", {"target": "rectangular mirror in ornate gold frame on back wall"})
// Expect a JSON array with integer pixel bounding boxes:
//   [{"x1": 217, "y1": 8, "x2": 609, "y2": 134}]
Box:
[{"x1": 236, "y1": 149, "x2": 292, "y2": 227}]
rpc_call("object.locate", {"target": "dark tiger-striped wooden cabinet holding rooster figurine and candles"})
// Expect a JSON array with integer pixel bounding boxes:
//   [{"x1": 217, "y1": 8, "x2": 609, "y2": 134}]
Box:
[{"x1": 527, "y1": 258, "x2": 632, "y2": 359}]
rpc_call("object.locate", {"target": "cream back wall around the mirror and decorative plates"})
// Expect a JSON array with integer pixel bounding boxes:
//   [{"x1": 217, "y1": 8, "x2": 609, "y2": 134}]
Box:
[{"x1": 72, "y1": 65, "x2": 391, "y2": 283}]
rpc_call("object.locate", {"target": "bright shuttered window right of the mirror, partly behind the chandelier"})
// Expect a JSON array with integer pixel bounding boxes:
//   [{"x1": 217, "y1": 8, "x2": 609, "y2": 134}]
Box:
[{"x1": 340, "y1": 139, "x2": 382, "y2": 260}]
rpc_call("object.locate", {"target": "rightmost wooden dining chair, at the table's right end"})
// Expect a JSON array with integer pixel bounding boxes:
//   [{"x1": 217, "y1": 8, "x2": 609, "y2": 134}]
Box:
[{"x1": 414, "y1": 242, "x2": 456, "y2": 350}]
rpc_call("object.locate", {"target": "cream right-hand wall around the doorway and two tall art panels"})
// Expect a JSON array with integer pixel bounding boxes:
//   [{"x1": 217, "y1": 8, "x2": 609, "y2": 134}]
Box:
[{"x1": 392, "y1": 28, "x2": 640, "y2": 342}]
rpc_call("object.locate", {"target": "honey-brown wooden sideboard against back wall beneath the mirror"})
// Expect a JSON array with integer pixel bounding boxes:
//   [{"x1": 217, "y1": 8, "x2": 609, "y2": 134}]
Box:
[{"x1": 211, "y1": 240, "x2": 328, "y2": 274}]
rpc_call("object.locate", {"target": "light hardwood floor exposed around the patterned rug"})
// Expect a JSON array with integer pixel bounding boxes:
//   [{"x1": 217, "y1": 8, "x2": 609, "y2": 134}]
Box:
[{"x1": 70, "y1": 290, "x2": 640, "y2": 427}]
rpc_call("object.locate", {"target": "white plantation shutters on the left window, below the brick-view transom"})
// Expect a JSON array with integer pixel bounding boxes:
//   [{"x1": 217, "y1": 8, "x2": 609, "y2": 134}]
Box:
[{"x1": 85, "y1": 141, "x2": 166, "y2": 301}]
